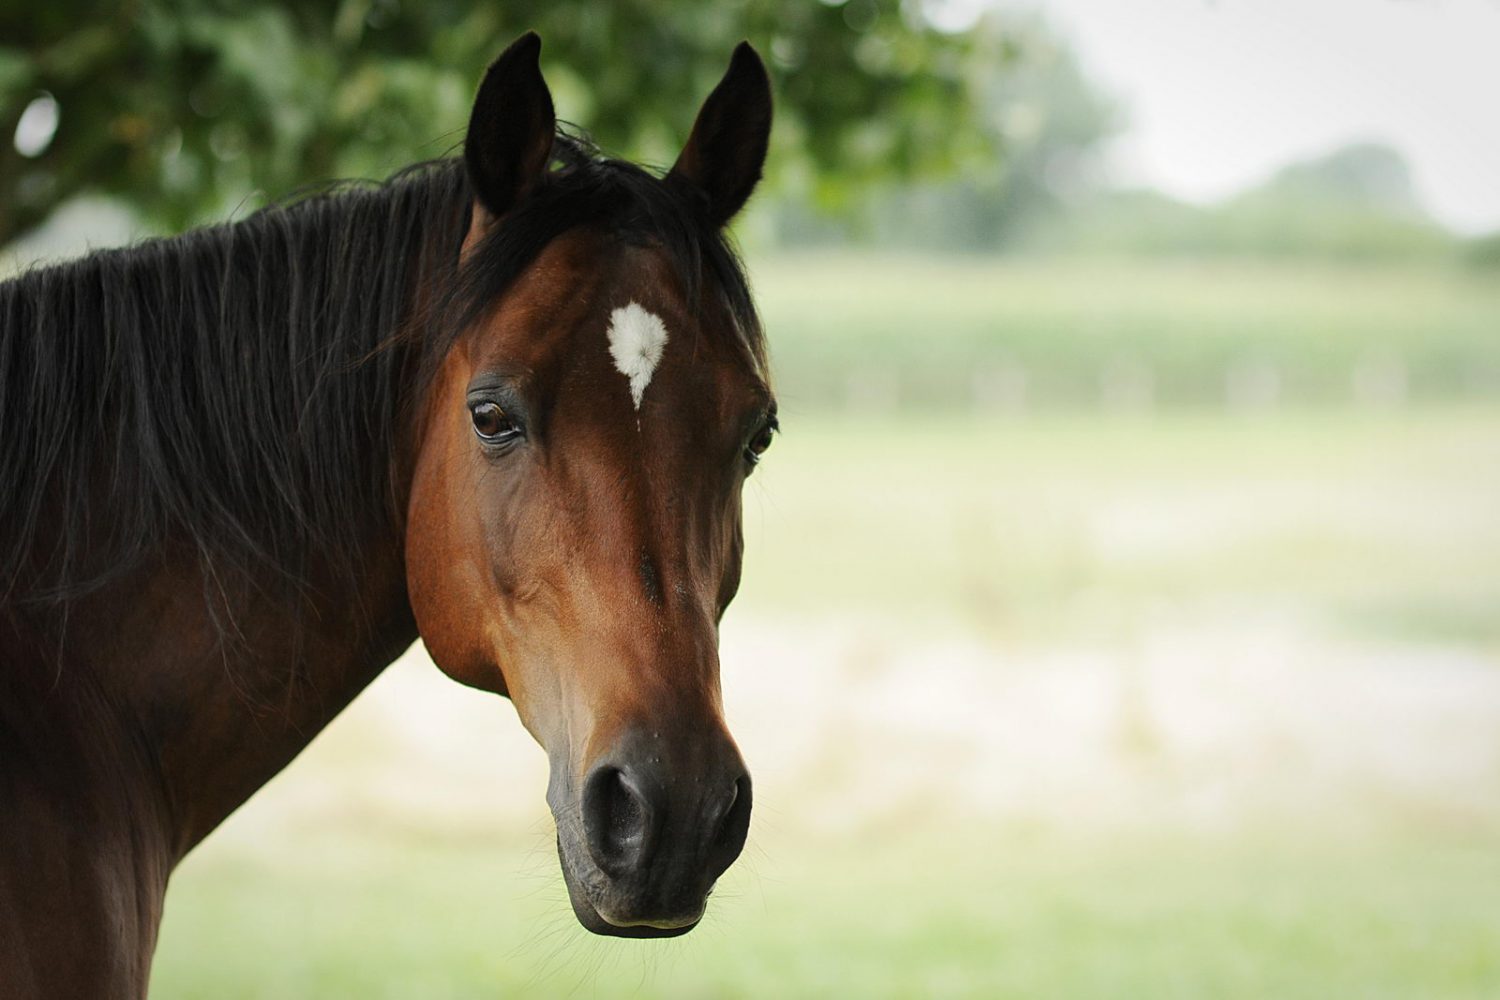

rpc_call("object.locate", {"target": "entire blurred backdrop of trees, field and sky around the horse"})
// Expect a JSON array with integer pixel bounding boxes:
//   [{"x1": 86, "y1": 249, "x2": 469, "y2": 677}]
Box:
[{"x1": 0, "y1": 0, "x2": 1500, "y2": 999}]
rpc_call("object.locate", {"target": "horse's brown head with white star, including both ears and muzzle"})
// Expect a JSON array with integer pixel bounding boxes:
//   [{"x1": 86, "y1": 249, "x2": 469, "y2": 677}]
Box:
[{"x1": 405, "y1": 34, "x2": 776, "y2": 937}]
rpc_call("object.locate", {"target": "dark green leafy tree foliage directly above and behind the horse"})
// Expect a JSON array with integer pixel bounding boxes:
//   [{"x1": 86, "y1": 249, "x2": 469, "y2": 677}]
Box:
[{"x1": 0, "y1": 0, "x2": 993, "y2": 246}]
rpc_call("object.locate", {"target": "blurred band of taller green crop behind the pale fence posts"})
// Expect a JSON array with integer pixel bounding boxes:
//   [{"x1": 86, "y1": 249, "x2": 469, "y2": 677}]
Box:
[{"x1": 753, "y1": 255, "x2": 1500, "y2": 409}]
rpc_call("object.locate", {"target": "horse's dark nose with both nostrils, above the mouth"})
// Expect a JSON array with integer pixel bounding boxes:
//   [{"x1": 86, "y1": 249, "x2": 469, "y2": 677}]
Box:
[{"x1": 581, "y1": 741, "x2": 750, "y2": 882}]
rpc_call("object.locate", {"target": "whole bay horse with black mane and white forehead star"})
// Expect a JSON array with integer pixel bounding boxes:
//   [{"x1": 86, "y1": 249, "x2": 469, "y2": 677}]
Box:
[{"x1": 0, "y1": 34, "x2": 777, "y2": 999}]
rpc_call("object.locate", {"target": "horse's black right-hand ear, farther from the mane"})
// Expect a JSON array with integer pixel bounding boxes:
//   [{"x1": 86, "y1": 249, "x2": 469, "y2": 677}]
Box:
[{"x1": 668, "y1": 42, "x2": 771, "y2": 226}]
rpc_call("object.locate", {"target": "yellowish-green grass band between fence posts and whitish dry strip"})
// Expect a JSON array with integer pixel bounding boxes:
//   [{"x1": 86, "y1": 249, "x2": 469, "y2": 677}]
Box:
[{"x1": 741, "y1": 406, "x2": 1500, "y2": 640}]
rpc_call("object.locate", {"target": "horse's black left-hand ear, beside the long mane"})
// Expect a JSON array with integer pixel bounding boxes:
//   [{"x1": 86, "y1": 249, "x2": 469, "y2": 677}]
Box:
[{"x1": 464, "y1": 31, "x2": 557, "y2": 216}]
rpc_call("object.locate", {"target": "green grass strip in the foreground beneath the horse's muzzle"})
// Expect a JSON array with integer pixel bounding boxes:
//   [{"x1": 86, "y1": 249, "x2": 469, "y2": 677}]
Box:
[{"x1": 153, "y1": 829, "x2": 1500, "y2": 1000}]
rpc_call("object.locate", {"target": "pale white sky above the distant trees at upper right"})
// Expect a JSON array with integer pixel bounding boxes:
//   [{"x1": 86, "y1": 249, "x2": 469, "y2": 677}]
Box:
[{"x1": 947, "y1": 0, "x2": 1500, "y2": 232}]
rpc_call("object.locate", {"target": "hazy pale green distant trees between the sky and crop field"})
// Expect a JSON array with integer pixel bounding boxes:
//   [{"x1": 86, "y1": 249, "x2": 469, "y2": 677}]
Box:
[{"x1": 776, "y1": 40, "x2": 1476, "y2": 268}]
